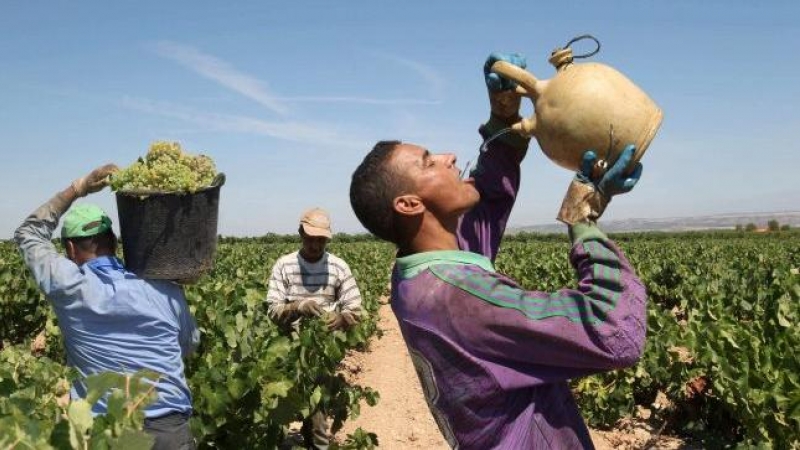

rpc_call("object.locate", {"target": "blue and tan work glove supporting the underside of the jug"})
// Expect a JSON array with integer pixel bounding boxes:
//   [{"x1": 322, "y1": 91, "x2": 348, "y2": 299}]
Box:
[{"x1": 557, "y1": 144, "x2": 642, "y2": 225}]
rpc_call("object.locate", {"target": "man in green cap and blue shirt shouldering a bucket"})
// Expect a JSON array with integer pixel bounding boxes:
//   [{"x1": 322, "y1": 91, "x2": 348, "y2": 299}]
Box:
[{"x1": 14, "y1": 165, "x2": 200, "y2": 450}]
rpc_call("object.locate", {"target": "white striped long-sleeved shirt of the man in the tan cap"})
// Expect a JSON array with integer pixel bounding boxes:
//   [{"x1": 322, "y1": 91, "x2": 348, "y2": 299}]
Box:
[{"x1": 267, "y1": 251, "x2": 361, "y2": 318}]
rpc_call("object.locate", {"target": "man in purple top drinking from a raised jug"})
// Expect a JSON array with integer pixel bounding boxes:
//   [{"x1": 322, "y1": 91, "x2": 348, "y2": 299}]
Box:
[{"x1": 350, "y1": 54, "x2": 647, "y2": 450}]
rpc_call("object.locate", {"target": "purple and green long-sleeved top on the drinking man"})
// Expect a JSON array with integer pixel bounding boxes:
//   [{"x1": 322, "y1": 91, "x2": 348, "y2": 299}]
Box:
[{"x1": 391, "y1": 121, "x2": 647, "y2": 450}]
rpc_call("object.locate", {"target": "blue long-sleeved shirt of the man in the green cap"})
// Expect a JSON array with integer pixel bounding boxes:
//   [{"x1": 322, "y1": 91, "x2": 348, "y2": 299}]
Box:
[{"x1": 14, "y1": 197, "x2": 200, "y2": 418}]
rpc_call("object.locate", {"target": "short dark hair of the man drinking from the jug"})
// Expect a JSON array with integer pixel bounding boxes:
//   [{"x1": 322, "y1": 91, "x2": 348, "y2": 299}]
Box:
[{"x1": 350, "y1": 141, "x2": 413, "y2": 244}]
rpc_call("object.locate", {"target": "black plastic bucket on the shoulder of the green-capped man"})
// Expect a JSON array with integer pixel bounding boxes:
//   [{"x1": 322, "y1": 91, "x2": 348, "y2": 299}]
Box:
[{"x1": 117, "y1": 173, "x2": 225, "y2": 282}]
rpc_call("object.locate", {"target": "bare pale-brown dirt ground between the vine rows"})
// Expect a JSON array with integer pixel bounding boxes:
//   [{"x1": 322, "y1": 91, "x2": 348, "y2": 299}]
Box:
[{"x1": 336, "y1": 299, "x2": 691, "y2": 450}]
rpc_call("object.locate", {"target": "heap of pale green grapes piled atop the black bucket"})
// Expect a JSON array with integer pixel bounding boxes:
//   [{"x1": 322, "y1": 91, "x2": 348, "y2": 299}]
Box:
[{"x1": 111, "y1": 141, "x2": 217, "y2": 193}]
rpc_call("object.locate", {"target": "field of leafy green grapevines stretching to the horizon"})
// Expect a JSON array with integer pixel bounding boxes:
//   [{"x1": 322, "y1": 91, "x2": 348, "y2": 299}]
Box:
[{"x1": 0, "y1": 231, "x2": 800, "y2": 449}]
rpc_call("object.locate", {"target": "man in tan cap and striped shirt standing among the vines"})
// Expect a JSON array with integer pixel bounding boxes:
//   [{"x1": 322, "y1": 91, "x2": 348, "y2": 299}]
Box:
[{"x1": 267, "y1": 208, "x2": 361, "y2": 449}]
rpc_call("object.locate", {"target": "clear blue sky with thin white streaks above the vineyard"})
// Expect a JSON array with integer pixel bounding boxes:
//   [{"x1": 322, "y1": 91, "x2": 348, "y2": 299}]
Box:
[{"x1": 0, "y1": 0, "x2": 800, "y2": 239}]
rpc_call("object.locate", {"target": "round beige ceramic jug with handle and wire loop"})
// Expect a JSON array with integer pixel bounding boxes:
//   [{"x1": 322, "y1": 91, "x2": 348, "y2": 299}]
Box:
[{"x1": 491, "y1": 36, "x2": 663, "y2": 173}]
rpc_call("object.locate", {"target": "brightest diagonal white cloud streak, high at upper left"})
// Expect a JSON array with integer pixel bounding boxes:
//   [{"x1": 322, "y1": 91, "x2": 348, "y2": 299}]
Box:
[{"x1": 155, "y1": 41, "x2": 289, "y2": 115}]
